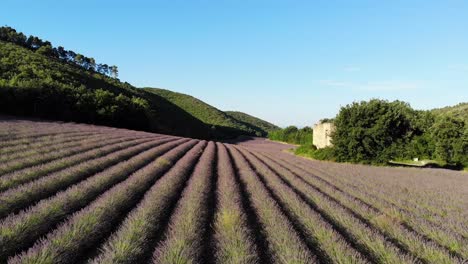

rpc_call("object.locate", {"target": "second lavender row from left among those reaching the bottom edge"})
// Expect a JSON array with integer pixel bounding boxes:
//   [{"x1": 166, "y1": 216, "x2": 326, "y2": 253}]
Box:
[{"x1": 85, "y1": 141, "x2": 206, "y2": 263}]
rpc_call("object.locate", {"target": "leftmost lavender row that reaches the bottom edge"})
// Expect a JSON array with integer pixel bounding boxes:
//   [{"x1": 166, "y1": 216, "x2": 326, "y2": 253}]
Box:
[{"x1": 9, "y1": 140, "x2": 200, "y2": 263}]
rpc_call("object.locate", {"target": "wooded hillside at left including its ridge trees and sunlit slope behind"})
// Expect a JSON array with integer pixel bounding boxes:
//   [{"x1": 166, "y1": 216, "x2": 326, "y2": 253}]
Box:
[{"x1": 0, "y1": 27, "x2": 274, "y2": 139}]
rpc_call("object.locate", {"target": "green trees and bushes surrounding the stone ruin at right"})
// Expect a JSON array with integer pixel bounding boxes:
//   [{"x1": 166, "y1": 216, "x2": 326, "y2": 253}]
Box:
[{"x1": 268, "y1": 99, "x2": 468, "y2": 168}]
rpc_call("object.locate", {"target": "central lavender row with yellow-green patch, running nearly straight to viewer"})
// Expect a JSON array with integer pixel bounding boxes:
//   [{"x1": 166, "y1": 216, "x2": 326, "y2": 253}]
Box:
[{"x1": 214, "y1": 143, "x2": 260, "y2": 264}]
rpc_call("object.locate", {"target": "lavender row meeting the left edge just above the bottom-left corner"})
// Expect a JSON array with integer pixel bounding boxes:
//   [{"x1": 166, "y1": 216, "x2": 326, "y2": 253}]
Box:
[{"x1": 0, "y1": 139, "x2": 188, "y2": 258}]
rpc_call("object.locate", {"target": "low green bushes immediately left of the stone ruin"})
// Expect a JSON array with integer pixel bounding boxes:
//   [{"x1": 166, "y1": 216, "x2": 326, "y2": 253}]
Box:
[{"x1": 268, "y1": 126, "x2": 312, "y2": 146}]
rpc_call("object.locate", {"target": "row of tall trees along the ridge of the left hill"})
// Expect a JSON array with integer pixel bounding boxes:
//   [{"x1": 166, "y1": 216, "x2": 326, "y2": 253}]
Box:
[{"x1": 0, "y1": 26, "x2": 119, "y2": 78}]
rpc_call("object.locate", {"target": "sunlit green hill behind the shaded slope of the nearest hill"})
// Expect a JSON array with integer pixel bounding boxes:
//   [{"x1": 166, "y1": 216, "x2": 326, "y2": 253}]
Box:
[{"x1": 144, "y1": 88, "x2": 274, "y2": 136}]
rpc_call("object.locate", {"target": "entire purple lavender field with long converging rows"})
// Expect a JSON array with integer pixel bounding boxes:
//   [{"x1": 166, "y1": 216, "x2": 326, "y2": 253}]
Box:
[{"x1": 0, "y1": 118, "x2": 468, "y2": 263}]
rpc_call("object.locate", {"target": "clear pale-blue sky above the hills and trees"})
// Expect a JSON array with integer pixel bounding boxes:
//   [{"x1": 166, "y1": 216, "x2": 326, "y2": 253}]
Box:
[{"x1": 0, "y1": 0, "x2": 468, "y2": 126}]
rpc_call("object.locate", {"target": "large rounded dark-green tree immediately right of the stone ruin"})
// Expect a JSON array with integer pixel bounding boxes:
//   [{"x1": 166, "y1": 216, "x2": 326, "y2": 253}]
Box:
[{"x1": 332, "y1": 99, "x2": 414, "y2": 163}]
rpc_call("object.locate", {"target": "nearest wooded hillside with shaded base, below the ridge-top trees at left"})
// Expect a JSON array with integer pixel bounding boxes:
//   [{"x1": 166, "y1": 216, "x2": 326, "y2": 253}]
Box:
[{"x1": 0, "y1": 38, "x2": 211, "y2": 138}]
